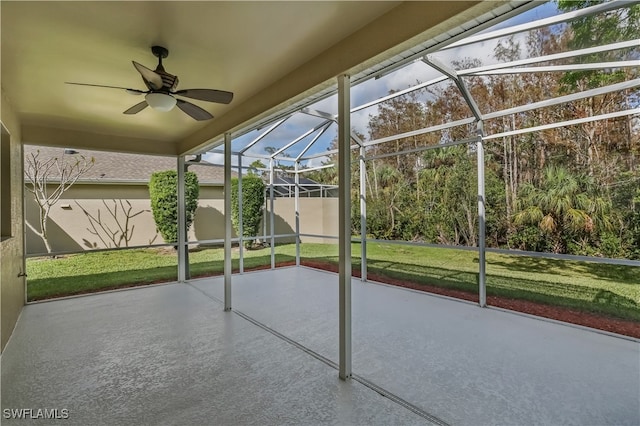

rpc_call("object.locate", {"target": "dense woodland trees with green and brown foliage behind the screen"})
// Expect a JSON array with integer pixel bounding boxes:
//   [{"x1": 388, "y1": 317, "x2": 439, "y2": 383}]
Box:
[{"x1": 310, "y1": 0, "x2": 640, "y2": 259}]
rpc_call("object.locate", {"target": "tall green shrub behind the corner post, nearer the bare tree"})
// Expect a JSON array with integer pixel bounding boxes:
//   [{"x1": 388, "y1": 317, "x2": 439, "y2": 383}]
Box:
[{"x1": 149, "y1": 170, "x2": 200, "y2": 243}]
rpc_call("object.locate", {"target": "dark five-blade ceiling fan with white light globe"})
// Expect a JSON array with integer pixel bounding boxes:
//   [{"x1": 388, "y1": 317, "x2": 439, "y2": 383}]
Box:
[{"x1": 66, "y1": 46, "x2": 233, "y2": 121}]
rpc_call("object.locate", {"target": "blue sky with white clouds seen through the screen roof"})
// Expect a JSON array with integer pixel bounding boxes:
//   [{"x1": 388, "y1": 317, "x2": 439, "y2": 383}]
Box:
[{"x1": 204, "y1": 2, "x2": 558, "y2": 167}]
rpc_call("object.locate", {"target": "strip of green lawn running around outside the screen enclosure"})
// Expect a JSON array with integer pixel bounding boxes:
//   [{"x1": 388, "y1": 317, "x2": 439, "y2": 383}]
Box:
[{"x1": 27, "y1": 243, "x2": 640, "y2": 321}]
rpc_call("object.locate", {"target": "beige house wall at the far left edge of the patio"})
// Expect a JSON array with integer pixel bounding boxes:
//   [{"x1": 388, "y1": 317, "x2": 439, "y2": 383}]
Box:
[{"x1": 0, "y1": 93, "x2": 25, "y2": 351}]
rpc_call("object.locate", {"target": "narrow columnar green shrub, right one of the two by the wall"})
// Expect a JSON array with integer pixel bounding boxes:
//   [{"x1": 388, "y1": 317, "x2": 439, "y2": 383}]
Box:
[{"x1": 231, "y1": 174, "x2": 264, "y2": 248}]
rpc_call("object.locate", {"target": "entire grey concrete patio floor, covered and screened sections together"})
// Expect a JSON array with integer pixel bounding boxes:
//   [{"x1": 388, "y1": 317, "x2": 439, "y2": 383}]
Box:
[{"x1": 1, "y1": 267, "x2": 640, "y2": 425}]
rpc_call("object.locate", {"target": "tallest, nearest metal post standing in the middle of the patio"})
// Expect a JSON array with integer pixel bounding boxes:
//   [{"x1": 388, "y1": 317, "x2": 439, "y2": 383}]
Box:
[{"x1": 338, "y1": 75, "x2": 351, "y2": 380}]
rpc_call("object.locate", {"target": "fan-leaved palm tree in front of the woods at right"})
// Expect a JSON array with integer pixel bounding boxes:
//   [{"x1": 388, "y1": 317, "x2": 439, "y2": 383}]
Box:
[{"x1": 514, "y1": 166, "x2": 612, "y2": 253}]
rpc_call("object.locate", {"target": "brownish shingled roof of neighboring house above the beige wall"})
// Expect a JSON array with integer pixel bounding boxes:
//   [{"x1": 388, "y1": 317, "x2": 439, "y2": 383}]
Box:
[{"x1": 24, "y1": 145, "x2": 237, "y2": 184}]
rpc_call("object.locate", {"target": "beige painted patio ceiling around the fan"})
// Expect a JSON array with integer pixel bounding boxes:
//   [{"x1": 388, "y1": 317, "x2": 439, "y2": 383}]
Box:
[{"x1": 0, "y1": 0, "x2": 495, "y2": 155}]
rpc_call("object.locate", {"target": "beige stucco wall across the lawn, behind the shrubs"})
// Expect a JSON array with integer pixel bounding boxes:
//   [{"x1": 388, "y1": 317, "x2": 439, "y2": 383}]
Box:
[{"x1": 26, "y1": 184, "x2": 338, "y2": 254}]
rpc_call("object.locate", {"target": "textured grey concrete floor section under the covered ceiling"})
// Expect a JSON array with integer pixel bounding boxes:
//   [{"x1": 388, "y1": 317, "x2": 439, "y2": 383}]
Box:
[{"x1": 1, "y1": 284, "x2": 426, "y2": 425}]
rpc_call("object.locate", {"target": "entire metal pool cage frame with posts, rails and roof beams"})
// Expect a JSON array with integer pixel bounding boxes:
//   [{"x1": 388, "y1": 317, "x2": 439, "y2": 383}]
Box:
[{"x1": 130, "y1": 1, "x2": 640, "y2": 379}]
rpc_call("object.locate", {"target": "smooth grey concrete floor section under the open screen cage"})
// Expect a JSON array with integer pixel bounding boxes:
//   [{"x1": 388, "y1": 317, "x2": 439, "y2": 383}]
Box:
[{"x1": 193, "y1": 268, "x2": 640, "y2": 425}]
